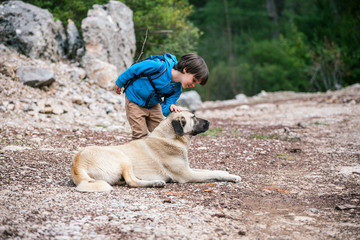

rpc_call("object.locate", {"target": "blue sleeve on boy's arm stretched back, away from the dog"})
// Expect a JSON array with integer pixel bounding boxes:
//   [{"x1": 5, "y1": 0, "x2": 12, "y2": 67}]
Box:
[{"x1": 115, "y1": 60, "x2": 161, "y2": 88}]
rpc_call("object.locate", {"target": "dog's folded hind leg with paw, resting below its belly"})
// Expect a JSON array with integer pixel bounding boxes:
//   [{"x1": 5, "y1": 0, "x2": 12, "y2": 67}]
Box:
[{"x1": 122, "y1": 164, "x2": 166, "y2": 187}]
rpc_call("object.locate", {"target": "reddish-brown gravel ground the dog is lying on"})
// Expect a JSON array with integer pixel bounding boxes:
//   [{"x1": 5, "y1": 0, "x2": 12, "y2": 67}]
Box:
[{"x1": 0, "y1": 89, "x2": 360, "y2": 239}]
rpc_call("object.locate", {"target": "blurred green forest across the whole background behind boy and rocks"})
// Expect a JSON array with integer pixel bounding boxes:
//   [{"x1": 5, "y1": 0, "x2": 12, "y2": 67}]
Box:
[{"x1": 25, "y1": 0, "x2": 360, "y2": 100}]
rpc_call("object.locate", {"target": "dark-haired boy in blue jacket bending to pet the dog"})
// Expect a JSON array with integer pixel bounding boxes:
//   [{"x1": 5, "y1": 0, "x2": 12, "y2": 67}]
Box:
[{"x1": 115, "y1": 53, "x2": 209, "y2": 139}]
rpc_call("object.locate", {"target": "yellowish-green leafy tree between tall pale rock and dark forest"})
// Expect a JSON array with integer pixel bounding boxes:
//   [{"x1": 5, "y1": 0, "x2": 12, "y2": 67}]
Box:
[{"x1": 123, "y1": 0, "x2": 200, "y2": 58}]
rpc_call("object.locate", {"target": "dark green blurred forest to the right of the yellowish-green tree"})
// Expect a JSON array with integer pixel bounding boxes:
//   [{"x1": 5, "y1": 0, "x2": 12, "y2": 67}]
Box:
[{"x1": 190, "y1": 0, "x2": 360, "y2": 100}]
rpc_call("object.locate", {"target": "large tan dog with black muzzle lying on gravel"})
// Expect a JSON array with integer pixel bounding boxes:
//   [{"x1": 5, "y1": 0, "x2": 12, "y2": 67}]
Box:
[{"x1": 71, "y1": 112, "x2": 241, "y2": 192}]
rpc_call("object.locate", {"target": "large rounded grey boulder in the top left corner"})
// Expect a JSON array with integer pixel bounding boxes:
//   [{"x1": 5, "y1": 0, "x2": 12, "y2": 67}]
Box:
[{"x1": 0, "y1": 1, "x2": 66, "y2": 61}]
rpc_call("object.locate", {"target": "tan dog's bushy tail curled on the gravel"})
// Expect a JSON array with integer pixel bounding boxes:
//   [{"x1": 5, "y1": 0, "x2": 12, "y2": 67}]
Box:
[{"x1": 71, "y1": 151, "x2": 112, "y2": 192}]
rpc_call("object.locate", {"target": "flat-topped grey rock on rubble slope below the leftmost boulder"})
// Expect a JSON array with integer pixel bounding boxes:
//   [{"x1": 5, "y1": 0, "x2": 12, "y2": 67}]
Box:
[{"x1": 16, "y1": 67, "x2": 55, "y2": 87}]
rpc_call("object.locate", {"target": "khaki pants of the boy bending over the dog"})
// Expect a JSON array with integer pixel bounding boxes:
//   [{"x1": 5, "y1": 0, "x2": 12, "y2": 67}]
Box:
[{"x1": 125, "y1": 96, "x2": 164, "y2": 139}]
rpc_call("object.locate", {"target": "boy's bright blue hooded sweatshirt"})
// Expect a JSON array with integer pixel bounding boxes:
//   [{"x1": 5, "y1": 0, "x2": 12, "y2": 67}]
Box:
[{"x1": 115, "y1": 53, "x2": 182, "y2": 117}]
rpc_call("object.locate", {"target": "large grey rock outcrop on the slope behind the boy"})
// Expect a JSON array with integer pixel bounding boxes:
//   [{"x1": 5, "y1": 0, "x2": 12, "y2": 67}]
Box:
[{"x1": 0, "y1": 0, "x2": 135, "y2": 89}]
